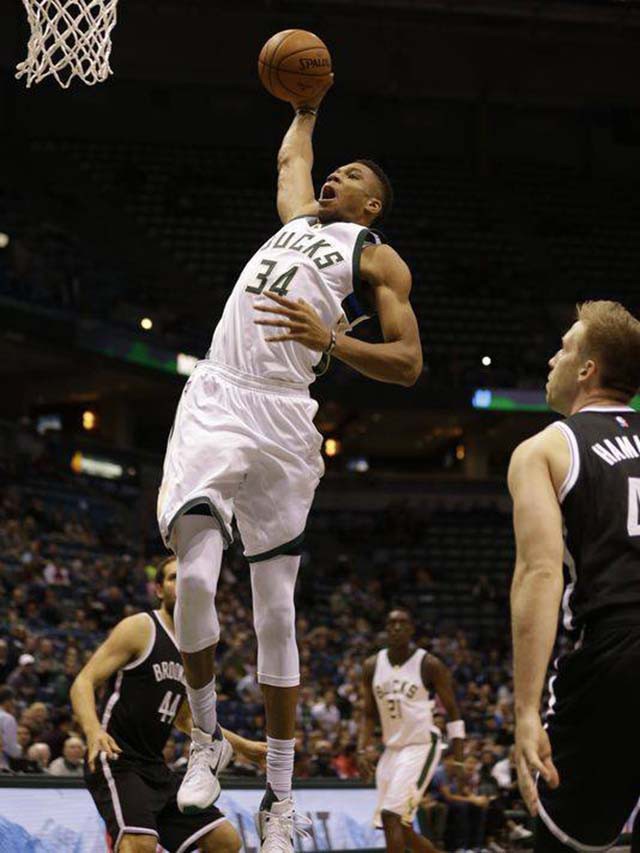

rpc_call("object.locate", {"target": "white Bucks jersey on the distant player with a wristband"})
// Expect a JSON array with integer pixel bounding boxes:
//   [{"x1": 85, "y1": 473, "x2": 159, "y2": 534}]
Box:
[{"x1": 373, "y1": 649, "x2": 433, "y2": 749}]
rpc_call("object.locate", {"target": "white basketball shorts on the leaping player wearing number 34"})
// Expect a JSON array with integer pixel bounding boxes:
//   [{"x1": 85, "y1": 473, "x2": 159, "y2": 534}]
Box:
[{"x1": 158, "y1": 361, "x2": 324, "y2": 562}]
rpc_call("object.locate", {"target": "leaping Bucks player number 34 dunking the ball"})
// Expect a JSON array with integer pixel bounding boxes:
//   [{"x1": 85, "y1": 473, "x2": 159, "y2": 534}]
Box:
[{"x1": 158, "y1": 75, "x2": 422, "y2": 851}]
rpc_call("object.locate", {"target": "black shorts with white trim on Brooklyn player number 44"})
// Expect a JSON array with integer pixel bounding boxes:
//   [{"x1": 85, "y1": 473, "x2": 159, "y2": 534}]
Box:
[{"x1": 85, "y1": 758, "x2": 226, "y2": 853}]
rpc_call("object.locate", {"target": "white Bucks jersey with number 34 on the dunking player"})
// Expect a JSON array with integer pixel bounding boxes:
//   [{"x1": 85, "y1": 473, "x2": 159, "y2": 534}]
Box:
[{"x1": 207, "y1": 216, "x2": 380, "y2": 387}]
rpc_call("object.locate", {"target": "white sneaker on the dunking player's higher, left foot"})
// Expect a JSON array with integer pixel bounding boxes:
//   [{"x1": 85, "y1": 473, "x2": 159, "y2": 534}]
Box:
[{"x1": 178, "y1": 728, "x2": 233, "y2": 814}]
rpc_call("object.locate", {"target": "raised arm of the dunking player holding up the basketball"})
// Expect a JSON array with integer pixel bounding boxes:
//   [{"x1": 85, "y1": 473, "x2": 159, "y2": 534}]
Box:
[{"x1": 278, "y1": 78, "x2": 333, "y2": 225}]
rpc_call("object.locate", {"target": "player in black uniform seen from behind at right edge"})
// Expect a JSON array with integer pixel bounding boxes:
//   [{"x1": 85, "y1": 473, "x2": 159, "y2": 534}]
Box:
[{"x1": 509, "y1": 301, "x2": 640, "y2": 853}]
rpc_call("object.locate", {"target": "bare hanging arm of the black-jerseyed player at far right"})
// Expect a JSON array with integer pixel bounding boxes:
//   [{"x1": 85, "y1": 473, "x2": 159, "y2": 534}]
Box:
[{"x1": 508, "y1": 429, "x2": 568, "y2": 814}]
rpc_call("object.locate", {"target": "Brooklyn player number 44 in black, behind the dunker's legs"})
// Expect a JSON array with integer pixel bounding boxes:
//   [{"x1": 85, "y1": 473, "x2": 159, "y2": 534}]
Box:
[{"x1": 71, "y1": 557, "x2": 266, "y2": 853}]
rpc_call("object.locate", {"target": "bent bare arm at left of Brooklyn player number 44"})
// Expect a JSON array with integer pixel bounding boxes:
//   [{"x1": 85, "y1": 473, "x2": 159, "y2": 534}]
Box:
[{"x1": 69, "y1": 613, "x2": 150, "y2": 771}]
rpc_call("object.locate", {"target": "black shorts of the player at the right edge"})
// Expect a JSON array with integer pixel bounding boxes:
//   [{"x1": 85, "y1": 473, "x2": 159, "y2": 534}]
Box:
[{"x1": 535, "y1": 623, "x2": 640, "y2": 853}]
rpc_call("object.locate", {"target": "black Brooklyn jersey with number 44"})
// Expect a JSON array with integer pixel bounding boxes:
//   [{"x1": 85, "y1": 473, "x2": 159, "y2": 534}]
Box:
[{"x1": 101, "y1": 611, "x2": 186, "y2": 763}]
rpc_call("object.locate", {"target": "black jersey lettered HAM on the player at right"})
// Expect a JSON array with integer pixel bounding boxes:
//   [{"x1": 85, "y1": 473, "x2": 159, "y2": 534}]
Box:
[{"x1": 555, "y1": 406, "x2": 640, "y2": 630}]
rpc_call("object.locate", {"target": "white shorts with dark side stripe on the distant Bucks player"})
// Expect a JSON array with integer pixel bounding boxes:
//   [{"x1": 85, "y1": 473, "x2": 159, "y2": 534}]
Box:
[{"x1": 374, "y1": 732, "x2": 442, "y2": 829}]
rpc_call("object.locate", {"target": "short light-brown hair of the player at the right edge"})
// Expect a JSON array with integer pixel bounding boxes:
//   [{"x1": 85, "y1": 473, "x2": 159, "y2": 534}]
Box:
[{"x1": 577, "y1": 300, "x2": 640, "y2": 399}]
